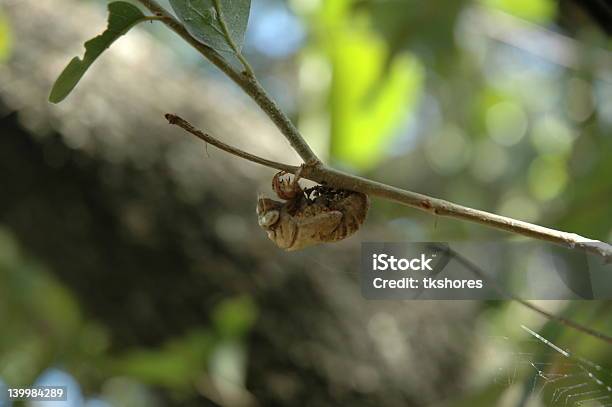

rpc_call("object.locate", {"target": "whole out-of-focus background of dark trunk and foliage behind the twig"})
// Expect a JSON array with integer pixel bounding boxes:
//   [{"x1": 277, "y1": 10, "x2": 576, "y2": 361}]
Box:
[{"x1": 0, "y1": 0, "x2": 612, "y2": 407}]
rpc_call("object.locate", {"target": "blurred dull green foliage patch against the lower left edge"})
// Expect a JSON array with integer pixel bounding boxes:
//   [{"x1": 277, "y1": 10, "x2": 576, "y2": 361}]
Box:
[{"x1": 0, "y1": 229, "x2": 89, "y2": 385}]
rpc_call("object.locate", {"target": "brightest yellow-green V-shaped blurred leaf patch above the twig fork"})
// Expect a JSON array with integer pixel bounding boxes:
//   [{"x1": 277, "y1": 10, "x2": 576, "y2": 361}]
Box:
[{"x1": 326, "y1": 24, "x2": 423, "y2": 169}]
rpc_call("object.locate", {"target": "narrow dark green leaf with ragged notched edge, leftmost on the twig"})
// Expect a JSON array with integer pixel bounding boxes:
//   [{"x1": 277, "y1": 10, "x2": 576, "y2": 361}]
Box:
[{"x1": 49, "y1": 1, "x2": 147, "y2": 103}]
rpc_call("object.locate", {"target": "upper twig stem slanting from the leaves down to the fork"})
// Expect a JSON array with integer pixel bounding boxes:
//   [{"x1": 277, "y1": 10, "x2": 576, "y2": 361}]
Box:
[{"x1": 138, "y1": 0, "x2": 320, "y2": 164}]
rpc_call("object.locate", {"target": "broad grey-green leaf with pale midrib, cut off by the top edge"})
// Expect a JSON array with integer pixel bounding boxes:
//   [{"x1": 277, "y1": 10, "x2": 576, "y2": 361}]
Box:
[{"x1": 170, "y1": 0, "x2": 251, "y2": 52}]
